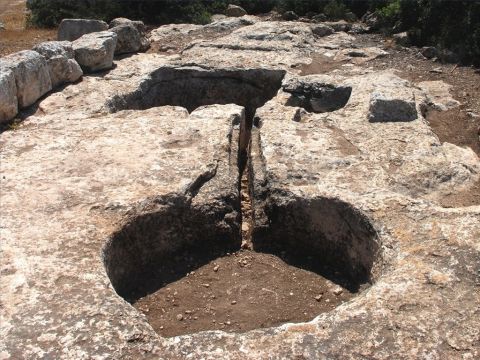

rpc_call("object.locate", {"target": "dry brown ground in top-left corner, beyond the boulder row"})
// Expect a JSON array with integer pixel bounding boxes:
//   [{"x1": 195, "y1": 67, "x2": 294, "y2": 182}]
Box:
[{"x1": 0, "y1": 0, "x2": 57, "y2": 56}]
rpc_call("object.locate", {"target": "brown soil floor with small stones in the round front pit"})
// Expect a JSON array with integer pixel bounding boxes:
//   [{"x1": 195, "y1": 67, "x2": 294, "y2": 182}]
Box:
[{"x1": 134, "y1": 250, "x2": 353, "y2": 337}]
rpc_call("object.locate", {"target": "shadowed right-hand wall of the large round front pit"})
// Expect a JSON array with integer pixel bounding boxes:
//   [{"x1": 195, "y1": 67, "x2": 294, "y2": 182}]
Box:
[{"x1": 252, "y1": 197, "x2": 380, "y2": 293}]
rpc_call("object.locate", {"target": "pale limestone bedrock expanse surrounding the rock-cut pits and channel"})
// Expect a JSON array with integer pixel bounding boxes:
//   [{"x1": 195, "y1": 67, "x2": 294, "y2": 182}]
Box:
[{"x1": 0, "y1": 17, "x2": 480, "y2": 359}]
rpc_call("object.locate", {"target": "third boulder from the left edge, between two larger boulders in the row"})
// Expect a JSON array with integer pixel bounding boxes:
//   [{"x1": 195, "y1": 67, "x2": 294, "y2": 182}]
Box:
[{"x1": 33, "y1": 41, "x2": 83, "y2": 88}]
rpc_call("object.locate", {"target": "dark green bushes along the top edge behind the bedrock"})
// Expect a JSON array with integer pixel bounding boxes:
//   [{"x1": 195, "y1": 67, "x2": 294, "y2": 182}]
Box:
[{"x1": 27, "y1": 0, "x2": 480, "y2": 65}]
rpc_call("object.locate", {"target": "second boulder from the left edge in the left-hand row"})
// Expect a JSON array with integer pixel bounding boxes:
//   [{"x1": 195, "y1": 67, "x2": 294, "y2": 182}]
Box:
[{"x1": 0, "y1": 50, "x2": 52, "y2": 108}]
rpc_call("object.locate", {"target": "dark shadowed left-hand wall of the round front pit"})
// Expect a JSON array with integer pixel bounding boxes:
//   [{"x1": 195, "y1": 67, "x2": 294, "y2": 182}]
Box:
[{"x1": 102, "y1": 196, "x2": 241, "y2": 303}]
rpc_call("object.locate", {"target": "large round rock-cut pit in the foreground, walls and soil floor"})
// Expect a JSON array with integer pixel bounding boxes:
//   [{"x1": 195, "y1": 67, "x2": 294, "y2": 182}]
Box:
[{"x1": 104, "y1": 194, "x2": 377, "y2": 337}]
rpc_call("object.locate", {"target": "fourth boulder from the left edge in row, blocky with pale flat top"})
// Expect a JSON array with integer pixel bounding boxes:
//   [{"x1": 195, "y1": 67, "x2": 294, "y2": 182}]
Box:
[{"x1": 73, "y1": 31, "x2": 117, "y2": 73}]
